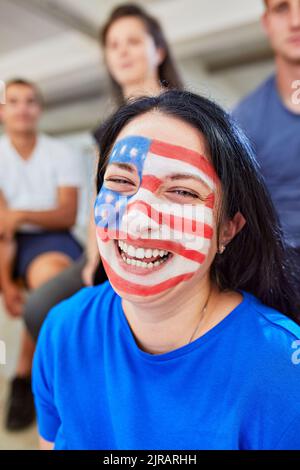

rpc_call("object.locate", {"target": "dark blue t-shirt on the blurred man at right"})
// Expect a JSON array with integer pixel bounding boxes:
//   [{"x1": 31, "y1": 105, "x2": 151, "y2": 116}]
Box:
[{"x1": 233, "y1": 76, "x2": 300, "y2": 248}]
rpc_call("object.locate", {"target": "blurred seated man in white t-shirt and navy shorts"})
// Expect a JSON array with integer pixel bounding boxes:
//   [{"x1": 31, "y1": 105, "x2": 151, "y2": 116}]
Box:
[{"x1": 0, "y1": 79, "x2": 81, "y2": 430}]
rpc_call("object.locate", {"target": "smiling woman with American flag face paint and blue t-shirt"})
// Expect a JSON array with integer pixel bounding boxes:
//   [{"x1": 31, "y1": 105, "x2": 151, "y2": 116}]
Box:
[{"x1": 33, "y1": 91, "x2": 300, "y2": 449}]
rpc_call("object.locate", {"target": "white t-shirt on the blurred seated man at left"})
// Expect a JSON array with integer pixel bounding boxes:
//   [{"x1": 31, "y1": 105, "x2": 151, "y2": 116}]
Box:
[{"x1": 0, "y1": 134, "x2": 83, "y2": 231}]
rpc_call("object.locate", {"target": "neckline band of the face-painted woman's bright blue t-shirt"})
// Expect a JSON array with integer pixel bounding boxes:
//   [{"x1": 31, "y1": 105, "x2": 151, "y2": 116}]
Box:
[{"x1": 118, "y1": 290, "x2": 250, "y2": 362}]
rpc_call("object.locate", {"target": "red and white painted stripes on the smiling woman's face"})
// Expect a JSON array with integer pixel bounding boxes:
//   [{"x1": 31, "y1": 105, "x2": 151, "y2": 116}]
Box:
[{"x1": 97, "y1": 141, "x2": 218, "y2": 296}]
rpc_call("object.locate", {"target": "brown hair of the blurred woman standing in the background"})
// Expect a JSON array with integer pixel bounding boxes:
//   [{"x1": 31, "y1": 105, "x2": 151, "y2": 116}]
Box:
[{"x1": 100, "y1": 3, "x2": 182, "y2": 105}]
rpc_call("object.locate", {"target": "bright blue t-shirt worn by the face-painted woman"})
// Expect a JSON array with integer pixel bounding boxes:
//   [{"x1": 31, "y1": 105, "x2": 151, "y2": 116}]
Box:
[{"x1": 33, "y1": 281, "x2": 300, "y2": 450}]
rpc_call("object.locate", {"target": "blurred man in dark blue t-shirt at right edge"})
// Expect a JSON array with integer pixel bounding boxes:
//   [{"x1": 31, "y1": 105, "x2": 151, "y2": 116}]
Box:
[{"x1": 234, "y1": 0, "x2": 300, "y2": 253}]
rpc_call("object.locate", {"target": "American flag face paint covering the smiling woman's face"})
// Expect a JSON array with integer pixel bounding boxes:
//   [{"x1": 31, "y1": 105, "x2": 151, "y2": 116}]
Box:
[{"x1": 95, "y1": 136, "x2": 219, "y2": 297}]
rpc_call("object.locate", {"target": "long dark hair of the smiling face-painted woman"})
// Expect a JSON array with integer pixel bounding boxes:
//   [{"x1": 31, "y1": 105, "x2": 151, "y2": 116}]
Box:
[{"x1": 97, "y1": 90, "x2": 300, "y2": 319}]
